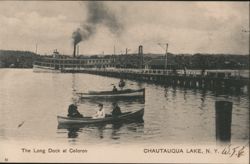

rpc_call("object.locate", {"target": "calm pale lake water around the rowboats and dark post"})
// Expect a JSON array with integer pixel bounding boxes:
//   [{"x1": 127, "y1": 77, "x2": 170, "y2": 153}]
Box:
[{"x1": 0, "y1": 69, "x2": 249, "y2": 145}]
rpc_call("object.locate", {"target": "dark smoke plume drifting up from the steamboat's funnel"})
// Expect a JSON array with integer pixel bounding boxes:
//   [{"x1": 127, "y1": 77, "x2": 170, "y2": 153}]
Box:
[{"x1": 72, "y1": 1, "x2": 123, "y2": 45}]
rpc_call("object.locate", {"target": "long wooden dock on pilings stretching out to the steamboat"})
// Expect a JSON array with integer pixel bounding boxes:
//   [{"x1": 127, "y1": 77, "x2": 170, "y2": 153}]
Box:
[{"x1": 62, "y1": 68, "x2": 249, "y2": 91}]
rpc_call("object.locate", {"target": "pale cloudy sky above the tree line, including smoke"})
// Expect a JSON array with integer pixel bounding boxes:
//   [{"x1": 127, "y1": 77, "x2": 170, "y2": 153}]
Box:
[{"x1": 0, "y1": 1, "x2": 249, "y2": 55}]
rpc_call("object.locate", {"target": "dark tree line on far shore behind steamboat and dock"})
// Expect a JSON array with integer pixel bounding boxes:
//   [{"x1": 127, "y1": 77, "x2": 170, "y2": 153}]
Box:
[{"x1": 0, "y1": 50, "x2": 249, "y2": 69}]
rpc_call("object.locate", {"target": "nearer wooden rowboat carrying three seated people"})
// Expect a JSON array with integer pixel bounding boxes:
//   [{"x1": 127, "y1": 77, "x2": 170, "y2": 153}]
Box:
[{"x1": 57, "y1": 108, "x2": 144, "y2": 125}]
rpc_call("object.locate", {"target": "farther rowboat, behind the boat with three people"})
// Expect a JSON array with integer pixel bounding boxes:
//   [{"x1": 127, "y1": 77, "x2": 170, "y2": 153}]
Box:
[{"x1": 76, "y1": 88, "x2": 145, "y2": 99}]
